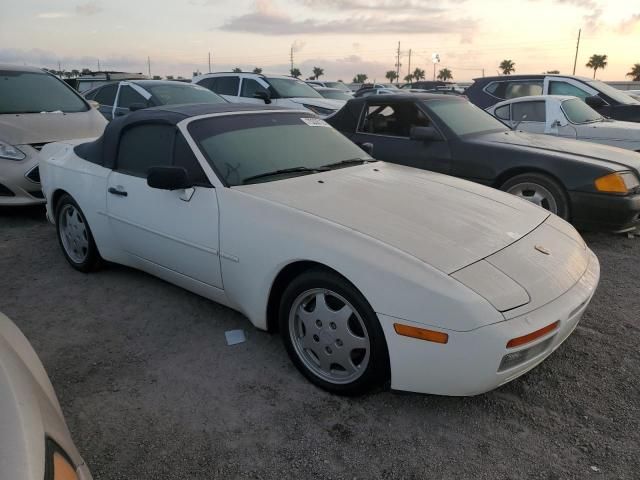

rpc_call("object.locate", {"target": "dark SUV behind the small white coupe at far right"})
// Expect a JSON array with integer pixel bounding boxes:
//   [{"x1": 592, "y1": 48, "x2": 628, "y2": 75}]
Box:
[{"x1": 465, "y1": 75, "x2": 640, "y2": 122}]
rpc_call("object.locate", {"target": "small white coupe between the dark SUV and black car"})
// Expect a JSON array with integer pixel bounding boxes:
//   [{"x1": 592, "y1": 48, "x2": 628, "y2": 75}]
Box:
[{"x1": 487, "y1": 95, "x2": 640, "y2": 151}]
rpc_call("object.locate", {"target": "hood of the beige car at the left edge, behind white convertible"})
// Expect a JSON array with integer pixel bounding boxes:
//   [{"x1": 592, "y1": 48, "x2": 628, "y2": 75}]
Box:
[{"x1": 0, "y1": 108, "x2": 107, "y2": 145}]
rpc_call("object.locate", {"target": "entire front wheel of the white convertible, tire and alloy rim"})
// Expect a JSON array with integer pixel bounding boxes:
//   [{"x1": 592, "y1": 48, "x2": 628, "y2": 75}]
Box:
[{"x1": 280, "y1": 270, "x2": 389, "y2": 395}]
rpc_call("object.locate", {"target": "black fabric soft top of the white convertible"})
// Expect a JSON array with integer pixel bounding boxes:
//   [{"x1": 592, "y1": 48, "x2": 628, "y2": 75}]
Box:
[{"x1": 74, "y1": 103, "x2": 290, "y2": 168}]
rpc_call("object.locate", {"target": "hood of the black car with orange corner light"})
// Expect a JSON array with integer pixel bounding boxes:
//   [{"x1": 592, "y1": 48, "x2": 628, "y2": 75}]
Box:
[{"x1": 470, "y1": 130, "x2": 640, "y2": 174}]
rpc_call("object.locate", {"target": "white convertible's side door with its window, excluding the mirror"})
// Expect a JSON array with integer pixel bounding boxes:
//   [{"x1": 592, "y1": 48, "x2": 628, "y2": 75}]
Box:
[{"x1": 106, "y1": 123, "x2": 222, "y2": 288}]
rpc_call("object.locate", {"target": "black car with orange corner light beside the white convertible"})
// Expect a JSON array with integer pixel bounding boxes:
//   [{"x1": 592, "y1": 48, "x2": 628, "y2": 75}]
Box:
[{"x1": 327, "y1": 94, "x2": 640, "y2": 231}]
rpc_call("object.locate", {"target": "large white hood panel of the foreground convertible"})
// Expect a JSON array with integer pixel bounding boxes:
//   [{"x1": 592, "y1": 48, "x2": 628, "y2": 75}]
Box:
[{"x1": 234, "y1": 162, "x2": 549, "y2": 274}]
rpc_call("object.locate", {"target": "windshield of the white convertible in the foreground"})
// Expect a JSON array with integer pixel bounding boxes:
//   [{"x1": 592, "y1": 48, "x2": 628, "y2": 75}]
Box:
[{"x1": 189, "y1": 113, "x2": 372, "y2": 186}]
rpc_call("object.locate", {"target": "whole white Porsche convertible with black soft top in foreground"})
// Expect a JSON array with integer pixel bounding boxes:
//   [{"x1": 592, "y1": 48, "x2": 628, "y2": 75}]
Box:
[{"x1": 41, "y1": 105, "x2": 599, "y2": 395}]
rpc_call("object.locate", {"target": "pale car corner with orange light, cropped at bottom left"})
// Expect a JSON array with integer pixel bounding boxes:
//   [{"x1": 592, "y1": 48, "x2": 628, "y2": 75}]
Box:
[{"x1": 0, "y1": 313, "x2": 92, "y2": 480}]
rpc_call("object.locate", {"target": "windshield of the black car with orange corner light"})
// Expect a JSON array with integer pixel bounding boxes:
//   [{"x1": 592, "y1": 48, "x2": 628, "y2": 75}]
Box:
[{"x1": 425, "y1": 99, "x2": 509, "y2": 136}]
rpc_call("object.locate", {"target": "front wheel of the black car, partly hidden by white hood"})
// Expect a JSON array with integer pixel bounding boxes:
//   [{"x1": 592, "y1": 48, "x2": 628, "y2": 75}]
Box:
[{"x1": 500, "y1": 173, "x2": 570, "y2": 220}]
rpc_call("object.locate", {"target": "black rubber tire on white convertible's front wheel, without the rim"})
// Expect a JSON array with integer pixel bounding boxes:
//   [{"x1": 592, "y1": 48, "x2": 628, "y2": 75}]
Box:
[{"x1": 279, "y1": 269, "x2": 390, "y2": 396}]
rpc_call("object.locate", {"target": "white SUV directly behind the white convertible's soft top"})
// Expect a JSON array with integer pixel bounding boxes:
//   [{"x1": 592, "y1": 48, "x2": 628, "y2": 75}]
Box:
[{"x1": 192, "y1": 73, "x2": 345, "y2": 117}]
